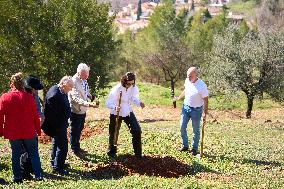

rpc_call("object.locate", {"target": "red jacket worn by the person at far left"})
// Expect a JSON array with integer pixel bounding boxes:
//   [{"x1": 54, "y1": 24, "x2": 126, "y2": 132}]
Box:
[{"x1": 0, "y1": 89, "x2": 41, "y2": 140}]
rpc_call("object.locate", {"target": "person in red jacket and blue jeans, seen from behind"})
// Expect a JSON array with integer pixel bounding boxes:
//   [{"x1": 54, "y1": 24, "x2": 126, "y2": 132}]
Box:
[{"x1": 0, "y1": 73, "x2": 43, "y2": 183}]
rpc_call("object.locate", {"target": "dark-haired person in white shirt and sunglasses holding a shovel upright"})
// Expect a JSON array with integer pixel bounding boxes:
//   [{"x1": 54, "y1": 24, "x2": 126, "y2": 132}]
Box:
[{"x1": 106, "y1": 72, "x2": 145, "y2": 158}]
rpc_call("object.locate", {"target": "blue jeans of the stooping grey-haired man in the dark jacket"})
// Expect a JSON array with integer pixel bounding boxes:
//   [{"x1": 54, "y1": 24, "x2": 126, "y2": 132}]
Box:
[{"x1": 51, "y1": 127, "x2": 68, "y2": 170}]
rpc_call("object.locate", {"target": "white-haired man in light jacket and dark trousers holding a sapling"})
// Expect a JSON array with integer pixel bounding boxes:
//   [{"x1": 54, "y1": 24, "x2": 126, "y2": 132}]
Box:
[{"x1": 68, "y1": 63, "x2": 97, "y2": 155}]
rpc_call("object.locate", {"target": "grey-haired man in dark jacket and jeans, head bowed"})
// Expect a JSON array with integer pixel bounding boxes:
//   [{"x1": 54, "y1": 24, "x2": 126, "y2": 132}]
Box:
[{"x1": 42, "y1": 76, "x2": 74, "y2": 175}]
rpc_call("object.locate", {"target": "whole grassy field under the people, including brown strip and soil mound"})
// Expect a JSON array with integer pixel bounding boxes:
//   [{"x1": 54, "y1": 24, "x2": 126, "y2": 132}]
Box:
[{"x1": 0, "y1": 84, "x2": 284, "y2": 188}]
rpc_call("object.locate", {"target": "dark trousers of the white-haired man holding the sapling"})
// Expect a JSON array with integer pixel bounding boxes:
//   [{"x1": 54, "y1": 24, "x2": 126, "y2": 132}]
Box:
[{"x1": 70, "y1": 113, "x2": 86, "y2": 152}]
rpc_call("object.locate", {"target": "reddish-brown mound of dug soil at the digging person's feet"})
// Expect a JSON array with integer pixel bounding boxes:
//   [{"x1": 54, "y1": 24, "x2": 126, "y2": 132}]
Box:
[{"x1": 92, "y1": 155, "x2": 190, "y2": 179}]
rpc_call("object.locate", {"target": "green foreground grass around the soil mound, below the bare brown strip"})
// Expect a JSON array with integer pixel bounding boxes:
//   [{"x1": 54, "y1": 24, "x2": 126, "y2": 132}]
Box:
[{"x1": 0, "y1": 120, "x2": 284, "y2": 188}]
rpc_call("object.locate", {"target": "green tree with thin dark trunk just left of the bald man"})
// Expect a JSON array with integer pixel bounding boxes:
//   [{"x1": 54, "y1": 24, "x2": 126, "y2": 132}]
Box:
[{"x1": 136, "y1": 2, "x2": 192, "y2": 106}]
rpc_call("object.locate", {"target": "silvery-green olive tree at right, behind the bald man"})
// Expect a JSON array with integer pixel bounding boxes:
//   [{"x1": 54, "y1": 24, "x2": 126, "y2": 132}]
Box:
[{"x1": 208, "y1": 28, "x2": 284, "y2": 118}]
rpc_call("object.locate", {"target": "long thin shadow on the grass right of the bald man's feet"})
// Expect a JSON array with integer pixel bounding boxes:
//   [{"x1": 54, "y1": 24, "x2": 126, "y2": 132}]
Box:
[{"x1": 205, "y1": 154, "x2": 282, "y2": 167}]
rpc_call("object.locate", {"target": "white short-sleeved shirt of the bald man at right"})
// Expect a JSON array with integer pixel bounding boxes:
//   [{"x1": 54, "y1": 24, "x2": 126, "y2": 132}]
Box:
[{"x1": 184, "y1": 78, "x2": 208, "y2": 108}]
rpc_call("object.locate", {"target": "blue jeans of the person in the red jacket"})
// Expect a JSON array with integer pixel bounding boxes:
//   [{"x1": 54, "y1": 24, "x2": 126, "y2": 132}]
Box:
[{"x1": 10, "y1": 137, "x2": 41, "y2": 180}]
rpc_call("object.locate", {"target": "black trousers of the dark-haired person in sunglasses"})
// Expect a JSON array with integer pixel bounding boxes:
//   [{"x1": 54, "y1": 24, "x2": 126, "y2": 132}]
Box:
[{"x1": 108, "y1": 112, "x2": 142, "y2": 156}]
